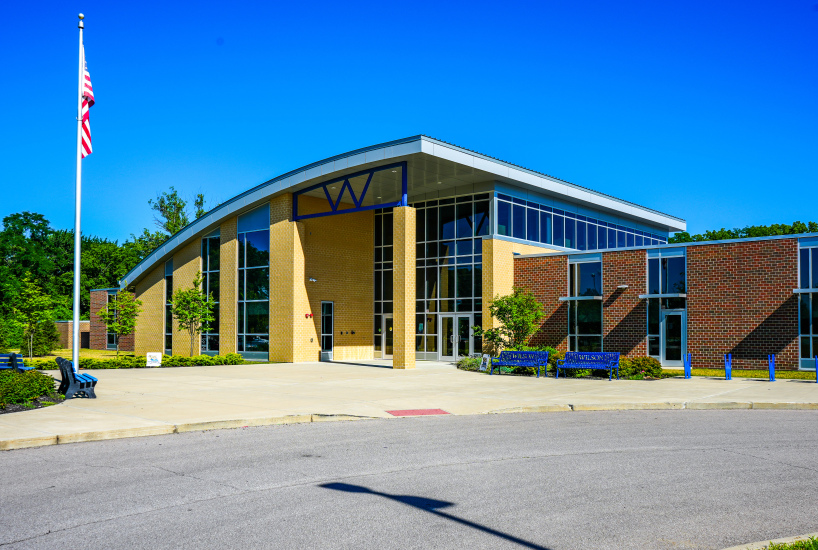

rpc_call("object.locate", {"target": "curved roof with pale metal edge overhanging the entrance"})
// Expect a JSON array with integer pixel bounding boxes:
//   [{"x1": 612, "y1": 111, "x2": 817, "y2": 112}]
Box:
[{"x1": 119, "y1": 135, "x2": 687, "y2": 288}]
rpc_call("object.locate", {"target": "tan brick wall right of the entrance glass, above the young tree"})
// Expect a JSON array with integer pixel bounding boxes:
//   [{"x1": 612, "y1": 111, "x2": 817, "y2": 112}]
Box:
[{"x1": 483, "y1": 239, "x2": 557, "y2": 329}]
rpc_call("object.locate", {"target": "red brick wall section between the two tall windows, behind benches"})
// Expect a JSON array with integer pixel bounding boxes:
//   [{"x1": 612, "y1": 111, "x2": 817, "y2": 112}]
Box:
[{"x1": 602, "y1": 250, "x2": 648, "y2": 357}]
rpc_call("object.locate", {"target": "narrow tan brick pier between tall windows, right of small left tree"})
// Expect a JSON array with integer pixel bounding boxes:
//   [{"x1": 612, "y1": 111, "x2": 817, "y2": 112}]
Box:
[{"x1": 219, "y1": 218, "x2": 239, "y2": 355}]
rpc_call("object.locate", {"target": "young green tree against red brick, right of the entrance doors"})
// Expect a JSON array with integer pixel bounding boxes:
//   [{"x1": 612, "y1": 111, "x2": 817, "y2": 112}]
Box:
[{"x1": 472, "y1": 287, "x2": 545, "y2": 353}]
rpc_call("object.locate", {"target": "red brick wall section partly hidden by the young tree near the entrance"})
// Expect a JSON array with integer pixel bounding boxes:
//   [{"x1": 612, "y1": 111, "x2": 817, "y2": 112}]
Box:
[{"x1": 514, "y1": 256, "x2": 568, "y2": 351}]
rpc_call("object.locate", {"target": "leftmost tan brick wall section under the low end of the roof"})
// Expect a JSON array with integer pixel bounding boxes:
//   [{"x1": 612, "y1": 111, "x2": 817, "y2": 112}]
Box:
[{"x1": 134, "y1": 263, "x2": 165, "y2": 355}]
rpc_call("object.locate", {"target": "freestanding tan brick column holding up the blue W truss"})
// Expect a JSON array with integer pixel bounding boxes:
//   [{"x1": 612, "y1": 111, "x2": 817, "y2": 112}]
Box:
[{"x1": 392, "y1": 206, "x2": 417, "y2": 369}]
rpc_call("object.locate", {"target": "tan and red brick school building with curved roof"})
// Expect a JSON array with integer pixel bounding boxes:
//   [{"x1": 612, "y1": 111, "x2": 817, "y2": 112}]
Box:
[{"x1": 99, "y1": 135, "x2": 818, "y2": 374}]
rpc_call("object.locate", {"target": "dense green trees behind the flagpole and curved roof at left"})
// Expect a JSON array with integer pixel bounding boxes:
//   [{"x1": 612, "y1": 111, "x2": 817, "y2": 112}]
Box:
[{"x1": 0, "y1": 187, "x2": 206, "y2": 355}]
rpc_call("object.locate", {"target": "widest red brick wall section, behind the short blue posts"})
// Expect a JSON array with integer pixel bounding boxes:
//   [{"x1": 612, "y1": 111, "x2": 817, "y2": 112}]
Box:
[{"x1": 687, "y1": 239, "x2": 798, "y2": 368}]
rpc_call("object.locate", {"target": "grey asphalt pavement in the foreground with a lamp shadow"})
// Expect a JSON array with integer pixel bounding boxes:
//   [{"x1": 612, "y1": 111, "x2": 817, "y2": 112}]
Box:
[{"x1": 0, "y1": 410, "x2": 818, "y2": 549}]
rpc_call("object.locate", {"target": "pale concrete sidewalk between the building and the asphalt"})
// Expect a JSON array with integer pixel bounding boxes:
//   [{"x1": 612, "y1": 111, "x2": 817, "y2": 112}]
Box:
[{"x1": 0, "y1": 361, "x2": 818, "y2": 450}]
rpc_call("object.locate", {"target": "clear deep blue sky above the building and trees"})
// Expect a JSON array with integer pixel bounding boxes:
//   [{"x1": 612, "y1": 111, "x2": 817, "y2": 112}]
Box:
[{"x1": 0, "y1": 0, "x2": 818, "y2": 241}]
